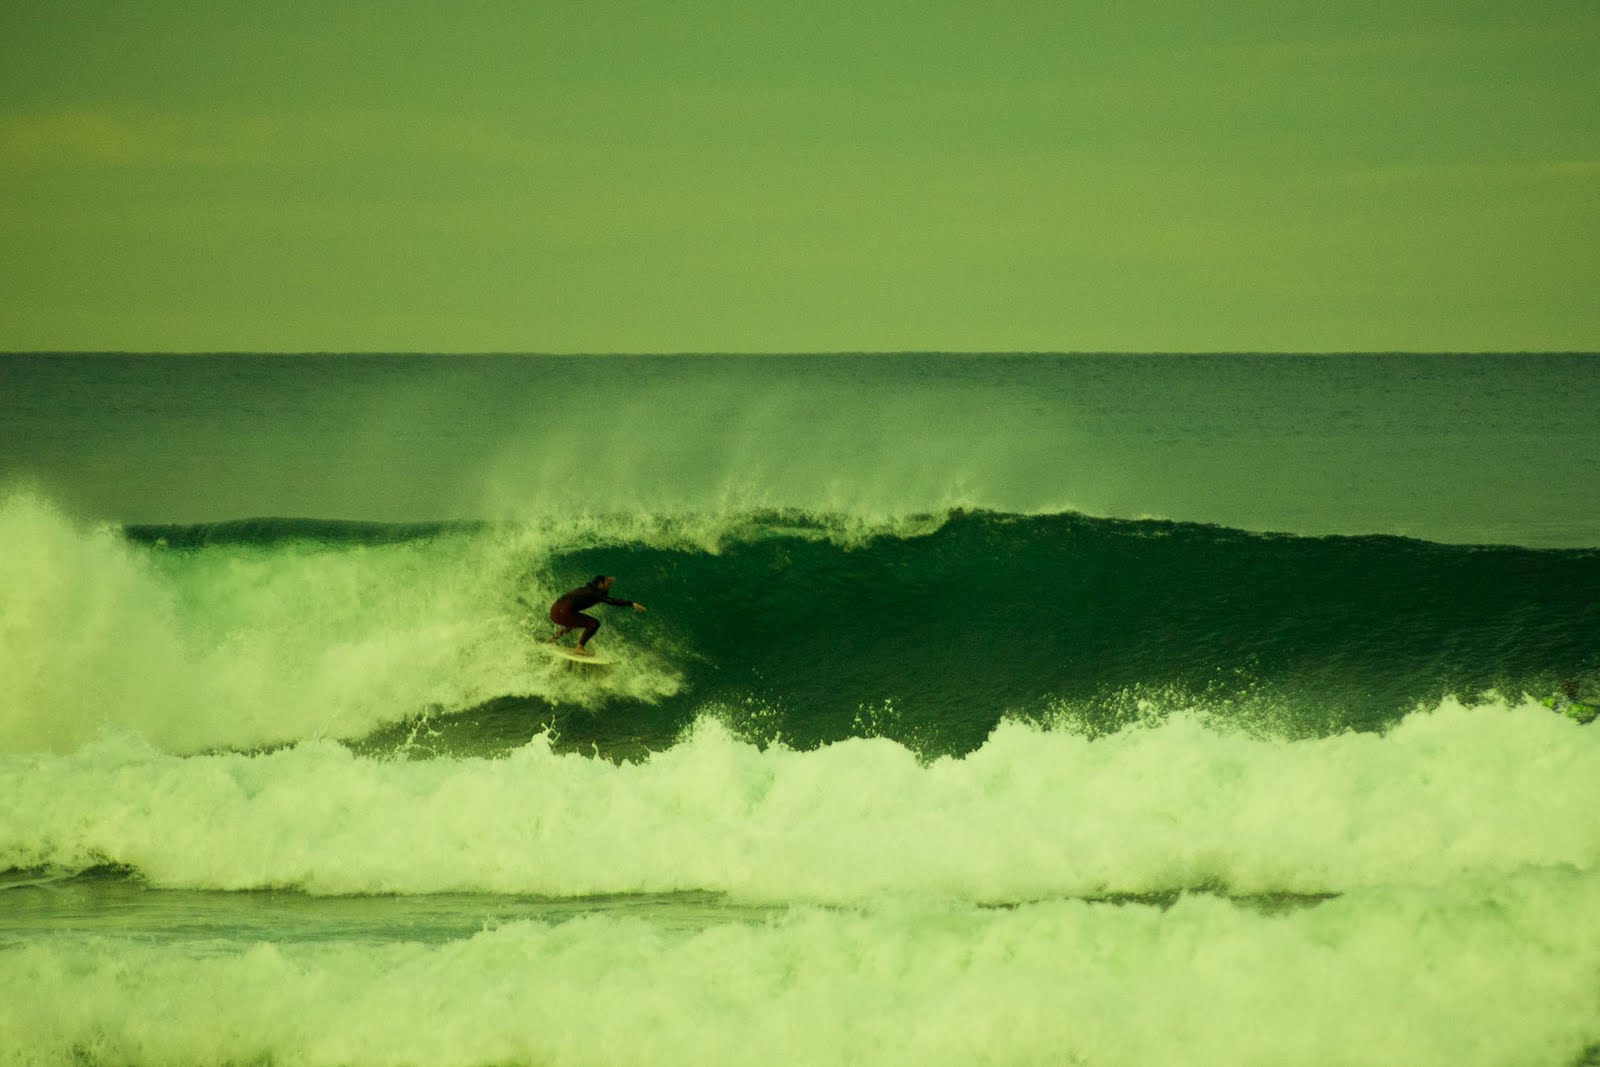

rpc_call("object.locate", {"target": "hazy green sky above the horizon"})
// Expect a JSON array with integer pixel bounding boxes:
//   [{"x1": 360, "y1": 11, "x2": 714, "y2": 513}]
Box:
[{"x1": 0, "y1": 0, "x2": 1600, "y2": 352}]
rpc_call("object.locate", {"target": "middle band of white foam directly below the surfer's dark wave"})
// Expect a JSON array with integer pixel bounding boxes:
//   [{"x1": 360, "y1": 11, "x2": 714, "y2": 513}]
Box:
[{"x1": 0, "y1": 702, "x2": 1600, "y2": 901}]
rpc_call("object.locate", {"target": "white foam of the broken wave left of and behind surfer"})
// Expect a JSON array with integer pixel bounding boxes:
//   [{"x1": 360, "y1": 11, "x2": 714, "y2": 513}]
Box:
[{"x1": 0, "y1": 493, "x2": 678, "y2": 752}]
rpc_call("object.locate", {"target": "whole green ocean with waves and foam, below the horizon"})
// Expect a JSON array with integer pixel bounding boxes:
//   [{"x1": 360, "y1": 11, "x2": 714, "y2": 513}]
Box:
[{"x1": 0, "y1": 354, "x2": 1600, "y2": 1067}]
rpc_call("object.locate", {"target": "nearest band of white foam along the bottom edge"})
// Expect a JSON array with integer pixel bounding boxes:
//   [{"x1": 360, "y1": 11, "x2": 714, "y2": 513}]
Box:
[{"x1": 0, "y1": 872, "x2": 1600, "y2": 1067}]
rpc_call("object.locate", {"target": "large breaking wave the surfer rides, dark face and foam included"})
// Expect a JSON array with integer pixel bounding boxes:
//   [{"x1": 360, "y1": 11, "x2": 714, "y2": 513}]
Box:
[{"x1": 0, "y1": 496, "x2": 1600, "y2": 758}]
